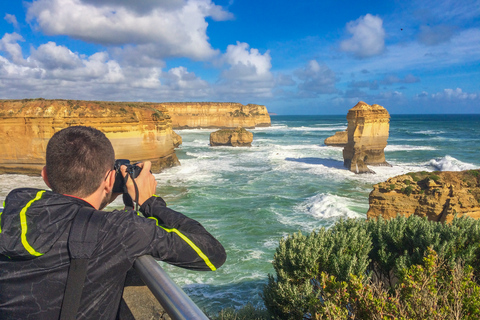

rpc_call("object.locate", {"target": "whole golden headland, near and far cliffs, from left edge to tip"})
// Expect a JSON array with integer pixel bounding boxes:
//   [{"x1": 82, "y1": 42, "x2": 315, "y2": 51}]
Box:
[{"x1": 0, "y1": 98, "x2": 271, "y2": 175}]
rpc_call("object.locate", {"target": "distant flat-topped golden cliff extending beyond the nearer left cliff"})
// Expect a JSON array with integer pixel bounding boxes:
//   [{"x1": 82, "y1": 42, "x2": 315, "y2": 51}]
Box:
[{"x1": 159, "y1": 102, "x2": 271, "y2": 129}]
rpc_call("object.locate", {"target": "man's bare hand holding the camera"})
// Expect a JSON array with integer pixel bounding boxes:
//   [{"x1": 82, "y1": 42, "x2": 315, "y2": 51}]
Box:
[{"x1": 120, "y1": 161, "x2": 157, "y2": 206}]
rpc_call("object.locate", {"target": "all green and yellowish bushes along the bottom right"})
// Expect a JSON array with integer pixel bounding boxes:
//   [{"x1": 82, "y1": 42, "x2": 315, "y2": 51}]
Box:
[{"x1": 215, "y1": 216, "x2": 480, "y2": 320}]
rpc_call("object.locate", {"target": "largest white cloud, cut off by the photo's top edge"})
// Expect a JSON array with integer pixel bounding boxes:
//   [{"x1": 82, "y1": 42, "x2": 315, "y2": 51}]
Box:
[{"x1": 27, "y1": 0, "x2": 232, "y2": 60}]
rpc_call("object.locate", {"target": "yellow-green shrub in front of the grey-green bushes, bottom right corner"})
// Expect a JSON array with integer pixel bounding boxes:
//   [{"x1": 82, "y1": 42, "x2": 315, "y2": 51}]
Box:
[{"x1": 286, "y1": 249, "x2": 480, "y2": 320}]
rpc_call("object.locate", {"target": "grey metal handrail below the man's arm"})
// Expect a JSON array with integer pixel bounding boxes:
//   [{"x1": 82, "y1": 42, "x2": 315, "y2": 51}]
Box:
[{"x1": 133, "y1": 256, "x2": 208, "y2": 320}]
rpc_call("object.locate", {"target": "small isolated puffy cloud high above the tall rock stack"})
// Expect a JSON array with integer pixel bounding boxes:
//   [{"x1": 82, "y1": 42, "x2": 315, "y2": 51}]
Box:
[{"x1": 340, "y1": 14, "x2": 385, "y2": 58}]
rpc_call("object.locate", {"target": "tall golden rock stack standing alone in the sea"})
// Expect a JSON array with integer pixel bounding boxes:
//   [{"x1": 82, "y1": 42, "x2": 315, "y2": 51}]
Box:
[{"x1": 343, "y1": 101, "x2": 390, "y2": 173}]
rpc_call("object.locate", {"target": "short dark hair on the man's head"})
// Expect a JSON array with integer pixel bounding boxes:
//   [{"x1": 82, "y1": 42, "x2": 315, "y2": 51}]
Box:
[{"x1": 46, "y1": 126, "x2": 115, "y2": 198}]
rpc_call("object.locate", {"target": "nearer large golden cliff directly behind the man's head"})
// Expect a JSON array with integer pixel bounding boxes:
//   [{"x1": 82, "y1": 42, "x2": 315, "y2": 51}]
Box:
[{"x1": 0, "y1": 99, "x2": 179, "y2": 174}]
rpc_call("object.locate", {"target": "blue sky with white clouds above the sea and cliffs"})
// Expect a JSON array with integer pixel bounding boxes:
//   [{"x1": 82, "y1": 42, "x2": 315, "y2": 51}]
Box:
[{"x1": 0, "y1": 0, "x2": 480, "y2": 115}]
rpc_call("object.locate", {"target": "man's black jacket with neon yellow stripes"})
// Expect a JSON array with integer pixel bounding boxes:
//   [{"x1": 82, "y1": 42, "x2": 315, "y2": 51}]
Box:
[{"x1": 0, "y1": 188, "x2": 226, "y2": 320}]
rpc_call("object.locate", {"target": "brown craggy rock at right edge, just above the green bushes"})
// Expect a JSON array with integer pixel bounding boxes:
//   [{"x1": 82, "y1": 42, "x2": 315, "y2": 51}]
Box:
[{"x1": 367, "y1": 169, "x2": 480, "y2": 222}]
